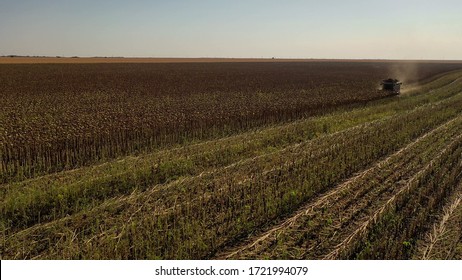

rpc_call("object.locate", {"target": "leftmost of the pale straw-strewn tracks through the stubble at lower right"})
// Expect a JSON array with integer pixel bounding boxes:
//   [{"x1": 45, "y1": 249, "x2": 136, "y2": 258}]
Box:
[{"x1": 218, "y1": 117, "x2": 461, "y2": 259}]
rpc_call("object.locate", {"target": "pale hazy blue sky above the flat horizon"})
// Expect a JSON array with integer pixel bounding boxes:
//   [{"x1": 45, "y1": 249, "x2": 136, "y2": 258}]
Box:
[{"x1": 0, "y1": 0, "x2": 462, "y2": 59}]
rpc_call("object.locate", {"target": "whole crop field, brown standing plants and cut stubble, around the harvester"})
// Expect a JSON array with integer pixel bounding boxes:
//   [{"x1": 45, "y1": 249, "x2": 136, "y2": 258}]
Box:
[{"x1": 0, "y1": 60, "x2": 462, "y2": 259}]
